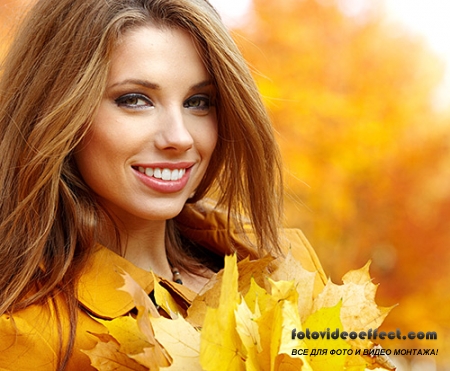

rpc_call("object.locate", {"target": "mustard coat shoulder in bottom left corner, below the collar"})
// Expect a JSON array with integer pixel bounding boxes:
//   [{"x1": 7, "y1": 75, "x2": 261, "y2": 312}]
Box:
[{"x1": 0, "y1": 296, "x2": 105, "y2": 371}]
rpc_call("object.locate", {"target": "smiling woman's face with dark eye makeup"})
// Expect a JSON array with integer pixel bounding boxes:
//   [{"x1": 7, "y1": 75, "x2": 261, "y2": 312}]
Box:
[{"x1": 75, "y1": 26, "x2": 217, "y2": 224}]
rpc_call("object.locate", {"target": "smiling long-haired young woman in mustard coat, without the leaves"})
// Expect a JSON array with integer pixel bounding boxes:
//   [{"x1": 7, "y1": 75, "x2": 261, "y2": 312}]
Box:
[{"x1": 0, "y1": 0, "x2": 322, "y2": 370}]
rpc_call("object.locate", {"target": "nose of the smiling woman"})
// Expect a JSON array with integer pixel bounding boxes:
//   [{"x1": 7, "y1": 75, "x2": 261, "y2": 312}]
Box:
[{"x1": 155, "y1": 108, "x2": 194, "y2": 152}]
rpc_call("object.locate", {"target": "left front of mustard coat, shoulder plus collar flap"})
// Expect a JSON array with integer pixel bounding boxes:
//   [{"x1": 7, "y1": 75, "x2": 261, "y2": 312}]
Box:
[{"x1": 0, "y1": 245, "x2": 194, "y2": 371}]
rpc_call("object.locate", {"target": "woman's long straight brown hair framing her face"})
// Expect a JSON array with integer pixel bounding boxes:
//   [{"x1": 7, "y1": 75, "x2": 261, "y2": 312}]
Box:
[{"x1": 0, "y1": 0, "x2": 282, "y2": 367}]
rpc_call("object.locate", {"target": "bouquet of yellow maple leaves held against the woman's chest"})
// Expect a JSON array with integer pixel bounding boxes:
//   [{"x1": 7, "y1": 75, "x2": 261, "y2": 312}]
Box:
[{"x1": 84, "y1": 254, "x2": 395, "y2": 371}]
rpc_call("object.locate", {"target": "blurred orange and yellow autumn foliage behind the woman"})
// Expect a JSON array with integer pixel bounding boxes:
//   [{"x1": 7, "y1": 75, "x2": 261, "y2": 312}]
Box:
[{"x1": 0, "y1": 0, "x2": 450, "y2": 371}]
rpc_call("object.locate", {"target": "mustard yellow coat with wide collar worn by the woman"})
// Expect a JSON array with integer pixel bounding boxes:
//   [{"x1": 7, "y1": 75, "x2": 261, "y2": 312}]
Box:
[{"x1": 0, "y1": 206, "x2": 326, "y2": 371}]
